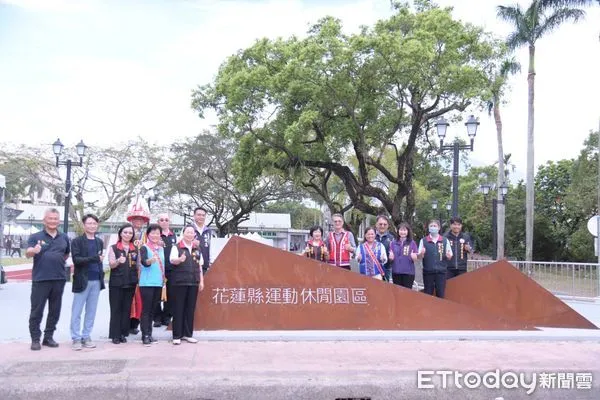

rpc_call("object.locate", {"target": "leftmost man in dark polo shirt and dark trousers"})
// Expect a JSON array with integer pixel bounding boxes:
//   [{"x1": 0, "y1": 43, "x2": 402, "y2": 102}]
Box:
[{"x1": 25, "y1": 208, "x2": 71, "y2": 350}]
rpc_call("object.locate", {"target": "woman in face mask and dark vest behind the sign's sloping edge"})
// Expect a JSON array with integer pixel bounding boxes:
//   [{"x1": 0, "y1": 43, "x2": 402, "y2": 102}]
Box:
[{"x1": 419, "y1": 219, "x2": 452, "y2": 298}]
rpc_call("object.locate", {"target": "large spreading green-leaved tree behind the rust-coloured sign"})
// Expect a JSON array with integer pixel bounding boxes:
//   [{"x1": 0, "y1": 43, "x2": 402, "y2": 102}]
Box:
[{"x1": 193, "y1": 1, "x2": 499, "y2": 222}]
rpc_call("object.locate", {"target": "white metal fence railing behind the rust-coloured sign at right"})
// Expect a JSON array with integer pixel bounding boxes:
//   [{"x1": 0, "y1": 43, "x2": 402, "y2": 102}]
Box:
[{"x1": 467, "y1": 260, "x2": 600, "y2": 297}]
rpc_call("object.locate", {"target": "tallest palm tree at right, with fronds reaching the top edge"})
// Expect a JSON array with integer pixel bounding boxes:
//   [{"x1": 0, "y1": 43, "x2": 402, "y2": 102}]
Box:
[{"x1": 497, "y1": 0, "x2": 589, "y2": 261}]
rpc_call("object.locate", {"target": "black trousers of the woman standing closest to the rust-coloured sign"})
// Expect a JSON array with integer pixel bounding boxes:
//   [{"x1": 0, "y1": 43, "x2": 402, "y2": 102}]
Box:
[{"x1": 170, "y1": 285, "x2": 198, "y2": 339}]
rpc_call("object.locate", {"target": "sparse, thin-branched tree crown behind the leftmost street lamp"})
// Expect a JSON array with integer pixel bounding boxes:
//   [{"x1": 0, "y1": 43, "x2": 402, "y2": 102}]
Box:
[{"x1": 0, "y1": 138, "x2": 165, "y2": 232}]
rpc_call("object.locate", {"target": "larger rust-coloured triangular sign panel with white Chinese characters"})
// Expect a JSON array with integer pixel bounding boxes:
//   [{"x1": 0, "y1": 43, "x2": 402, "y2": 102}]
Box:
[{"x1": 194, "y1": 237, "x2": 535, "y2": 330}]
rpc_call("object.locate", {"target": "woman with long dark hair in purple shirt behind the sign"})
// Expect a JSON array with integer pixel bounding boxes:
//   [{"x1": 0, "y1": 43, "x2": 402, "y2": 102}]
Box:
[{"x1": 388, "y1": 222, "x2": 418, "y2": 289}]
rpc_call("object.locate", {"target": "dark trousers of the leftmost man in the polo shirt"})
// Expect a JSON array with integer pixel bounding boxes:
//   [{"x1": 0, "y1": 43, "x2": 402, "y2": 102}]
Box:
[{"x1": 29, "y1": 280, "x2": 65, "y2": 341}]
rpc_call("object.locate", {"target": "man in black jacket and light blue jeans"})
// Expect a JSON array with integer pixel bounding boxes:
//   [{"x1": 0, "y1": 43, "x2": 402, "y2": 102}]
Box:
[{"x1": 71, "y1": 214, "x2": 104, "y2": 350}]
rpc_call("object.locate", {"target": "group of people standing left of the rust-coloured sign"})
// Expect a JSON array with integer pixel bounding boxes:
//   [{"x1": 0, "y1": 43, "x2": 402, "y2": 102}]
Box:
[{"x1": 26, "y1": 199, "x2": 211, "y2": 350}]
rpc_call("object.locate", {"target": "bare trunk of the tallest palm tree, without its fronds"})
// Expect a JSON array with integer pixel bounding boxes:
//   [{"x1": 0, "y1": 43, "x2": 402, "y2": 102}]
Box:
[{"x1": 525, "y1": 45, "x2": 535, "y2": 261}]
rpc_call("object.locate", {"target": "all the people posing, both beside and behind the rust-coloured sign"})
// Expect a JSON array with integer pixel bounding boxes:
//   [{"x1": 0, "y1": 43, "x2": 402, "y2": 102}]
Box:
[{"x1": 26, "y1": 203, "x2": 473, "y2": 350}]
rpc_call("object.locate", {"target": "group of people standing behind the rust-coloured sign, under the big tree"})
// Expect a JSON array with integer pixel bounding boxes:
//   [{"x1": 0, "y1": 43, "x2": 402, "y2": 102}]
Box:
[{"x1": 304, "y1": 214, "x2": 473, "y2": 298}]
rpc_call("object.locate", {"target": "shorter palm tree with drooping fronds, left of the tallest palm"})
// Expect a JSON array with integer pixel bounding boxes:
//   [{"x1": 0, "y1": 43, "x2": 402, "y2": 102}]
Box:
[{"x1": 488, "y1": 58, "x2": 521, "y2": 259}]
